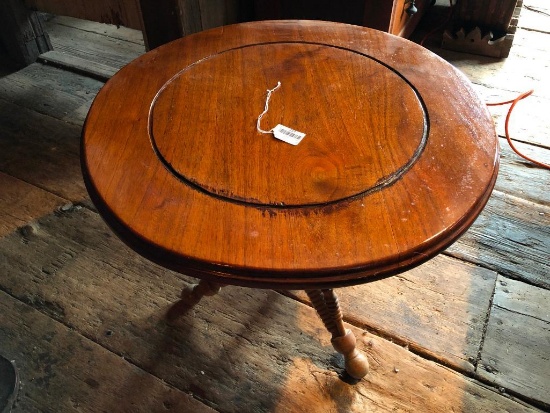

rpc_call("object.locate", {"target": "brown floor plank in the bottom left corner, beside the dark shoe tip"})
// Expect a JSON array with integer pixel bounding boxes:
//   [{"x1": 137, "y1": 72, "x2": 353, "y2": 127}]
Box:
[{"x1": 0, "y1": 291, "x2": 215, "y2": 413}]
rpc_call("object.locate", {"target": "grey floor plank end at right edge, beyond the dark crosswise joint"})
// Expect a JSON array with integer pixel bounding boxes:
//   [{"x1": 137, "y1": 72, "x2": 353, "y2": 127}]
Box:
[{"x1": 478, "y1": 277, "x2": 550, "y2": 409}]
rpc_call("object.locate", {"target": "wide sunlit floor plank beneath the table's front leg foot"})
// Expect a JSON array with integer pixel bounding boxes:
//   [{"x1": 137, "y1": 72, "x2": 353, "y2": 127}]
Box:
[{"x1": 0, "y1": 207, "x2": 535, "y2": 412}]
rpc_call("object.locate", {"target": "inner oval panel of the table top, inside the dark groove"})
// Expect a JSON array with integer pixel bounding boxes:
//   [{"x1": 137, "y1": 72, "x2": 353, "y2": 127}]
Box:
[{"x1": 149, "y1": 42, "x2": 428, "y2": 208}]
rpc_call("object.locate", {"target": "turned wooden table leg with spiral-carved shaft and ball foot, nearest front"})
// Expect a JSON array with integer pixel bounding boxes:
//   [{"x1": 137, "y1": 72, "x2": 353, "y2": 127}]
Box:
[{"x1": 306, "y1": 289, "x2": 369, "y2": 380}]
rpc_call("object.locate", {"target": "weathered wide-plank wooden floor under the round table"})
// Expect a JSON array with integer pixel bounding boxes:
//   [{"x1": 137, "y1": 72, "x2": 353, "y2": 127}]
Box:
[{"x1": 0, "y1": 0, "x2": 550, "y2": 413}]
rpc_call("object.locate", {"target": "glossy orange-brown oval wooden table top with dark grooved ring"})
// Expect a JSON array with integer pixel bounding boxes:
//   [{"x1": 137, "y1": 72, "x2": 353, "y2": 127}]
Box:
[{"x1": 82, "y1": 21, "x2": 499, "y2": 289}]
